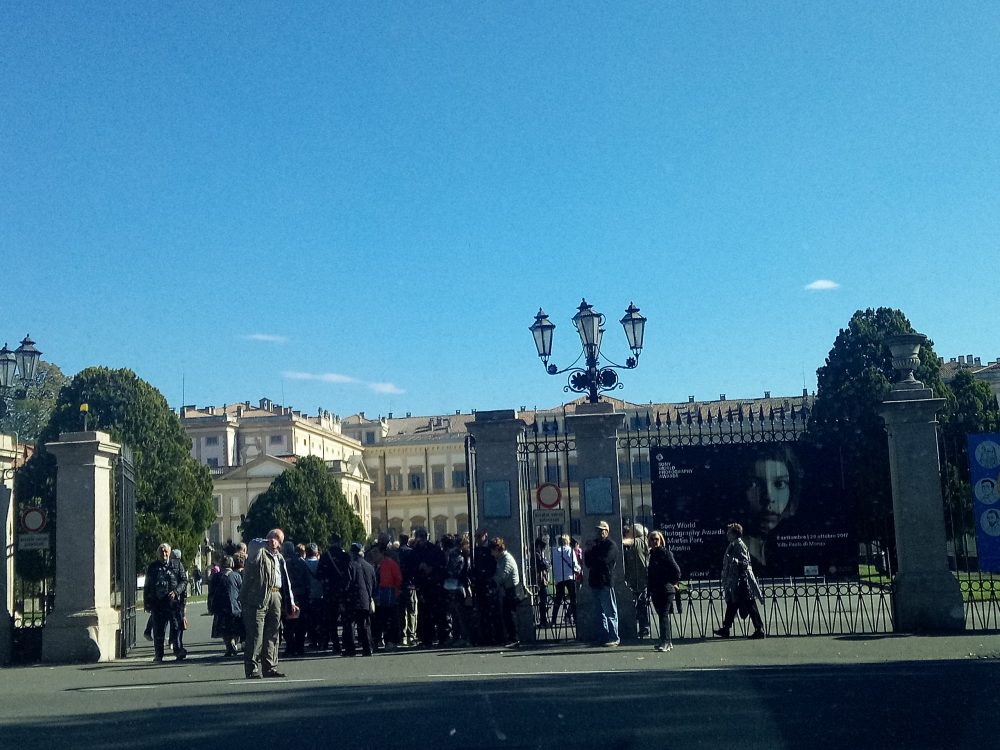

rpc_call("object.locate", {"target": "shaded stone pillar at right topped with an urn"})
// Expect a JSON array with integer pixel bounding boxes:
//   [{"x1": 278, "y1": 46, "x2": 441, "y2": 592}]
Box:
[{"x1": 879, "y1": 334, "x2": 965, "y2": 632}]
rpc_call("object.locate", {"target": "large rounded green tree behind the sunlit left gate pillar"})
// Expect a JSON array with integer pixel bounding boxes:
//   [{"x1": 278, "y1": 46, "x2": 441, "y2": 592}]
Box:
[{"x1": 17, "y1": 367, "x2": 215, "y2": 568}]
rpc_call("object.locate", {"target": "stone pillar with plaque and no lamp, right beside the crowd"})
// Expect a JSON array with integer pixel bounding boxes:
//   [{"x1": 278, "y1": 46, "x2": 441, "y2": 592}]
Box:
[{"x1": 468, "y1": 409, "x2": 535, "y2": 643}]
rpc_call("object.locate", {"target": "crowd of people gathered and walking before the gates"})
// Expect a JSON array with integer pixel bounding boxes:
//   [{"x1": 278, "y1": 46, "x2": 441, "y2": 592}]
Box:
[{"x1": 145, "y1": 521, "x2": 763, "y2": 679}]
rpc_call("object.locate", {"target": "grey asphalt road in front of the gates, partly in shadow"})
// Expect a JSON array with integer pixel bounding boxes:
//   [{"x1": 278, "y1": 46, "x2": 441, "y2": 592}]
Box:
[{"x1": 0, "y1": 605, "x2": 1000, "y2": 750}]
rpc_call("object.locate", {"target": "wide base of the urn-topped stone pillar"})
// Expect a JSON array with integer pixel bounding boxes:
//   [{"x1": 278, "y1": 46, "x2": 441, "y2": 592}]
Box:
[{"x1": 893, "y1": 572, "x2": 965, "y2": 633}]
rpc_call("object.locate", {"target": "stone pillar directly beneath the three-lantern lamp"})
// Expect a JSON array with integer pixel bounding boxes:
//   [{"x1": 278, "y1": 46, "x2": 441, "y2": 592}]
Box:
[{"x1": 566, "y1": 402, "x2": 638, "y2": 643}]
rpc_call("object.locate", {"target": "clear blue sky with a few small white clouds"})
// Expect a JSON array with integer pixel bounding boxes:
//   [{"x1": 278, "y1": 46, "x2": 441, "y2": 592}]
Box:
[{"x1": 0, "y1": 2, "x2": 1000, "y2": 415}]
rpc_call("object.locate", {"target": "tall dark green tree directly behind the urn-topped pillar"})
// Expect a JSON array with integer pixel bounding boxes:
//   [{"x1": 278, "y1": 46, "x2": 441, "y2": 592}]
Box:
[{"x1": 806, "y1": 307, "x2": 949, "y2": 543}]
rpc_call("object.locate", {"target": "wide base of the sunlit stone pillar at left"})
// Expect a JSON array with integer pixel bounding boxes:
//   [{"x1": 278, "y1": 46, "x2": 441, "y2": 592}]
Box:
[{"x1": 42, "y1": 607, "x2": 119, "y2": 664}]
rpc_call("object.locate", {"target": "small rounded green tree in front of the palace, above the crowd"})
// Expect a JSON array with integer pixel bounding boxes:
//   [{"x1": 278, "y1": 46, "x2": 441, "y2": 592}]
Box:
[{"x1": 240, "y1": 456, "x2": 365, "y2": 546}]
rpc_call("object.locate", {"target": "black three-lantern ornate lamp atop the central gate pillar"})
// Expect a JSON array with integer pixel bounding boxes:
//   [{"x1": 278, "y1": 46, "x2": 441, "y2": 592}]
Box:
[{"x1": 528, "y1": 300, "x2": 646, "y2": 404}]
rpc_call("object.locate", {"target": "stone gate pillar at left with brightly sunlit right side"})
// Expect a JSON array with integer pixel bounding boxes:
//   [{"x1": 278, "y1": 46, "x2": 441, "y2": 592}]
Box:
[{"x1": 42, "y1": 432, "x2": 121, "y2": 662}]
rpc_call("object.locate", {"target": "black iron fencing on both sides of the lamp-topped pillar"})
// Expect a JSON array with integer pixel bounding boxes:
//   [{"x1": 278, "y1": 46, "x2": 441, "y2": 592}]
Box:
[{"x1": 519, "y1": 406, "x2": 893, "y2": 640}]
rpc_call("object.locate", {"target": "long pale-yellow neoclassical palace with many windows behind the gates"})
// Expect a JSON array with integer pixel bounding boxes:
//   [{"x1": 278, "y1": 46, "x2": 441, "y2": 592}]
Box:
[{"x1": 180, "y1": 355, "x2": 1000, "y2": 544}]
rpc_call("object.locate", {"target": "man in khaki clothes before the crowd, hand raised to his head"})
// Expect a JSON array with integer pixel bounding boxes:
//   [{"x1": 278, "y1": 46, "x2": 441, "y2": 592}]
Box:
[{"x1": 240, "y1": 529, "x2": 299, "y2": 680}]
